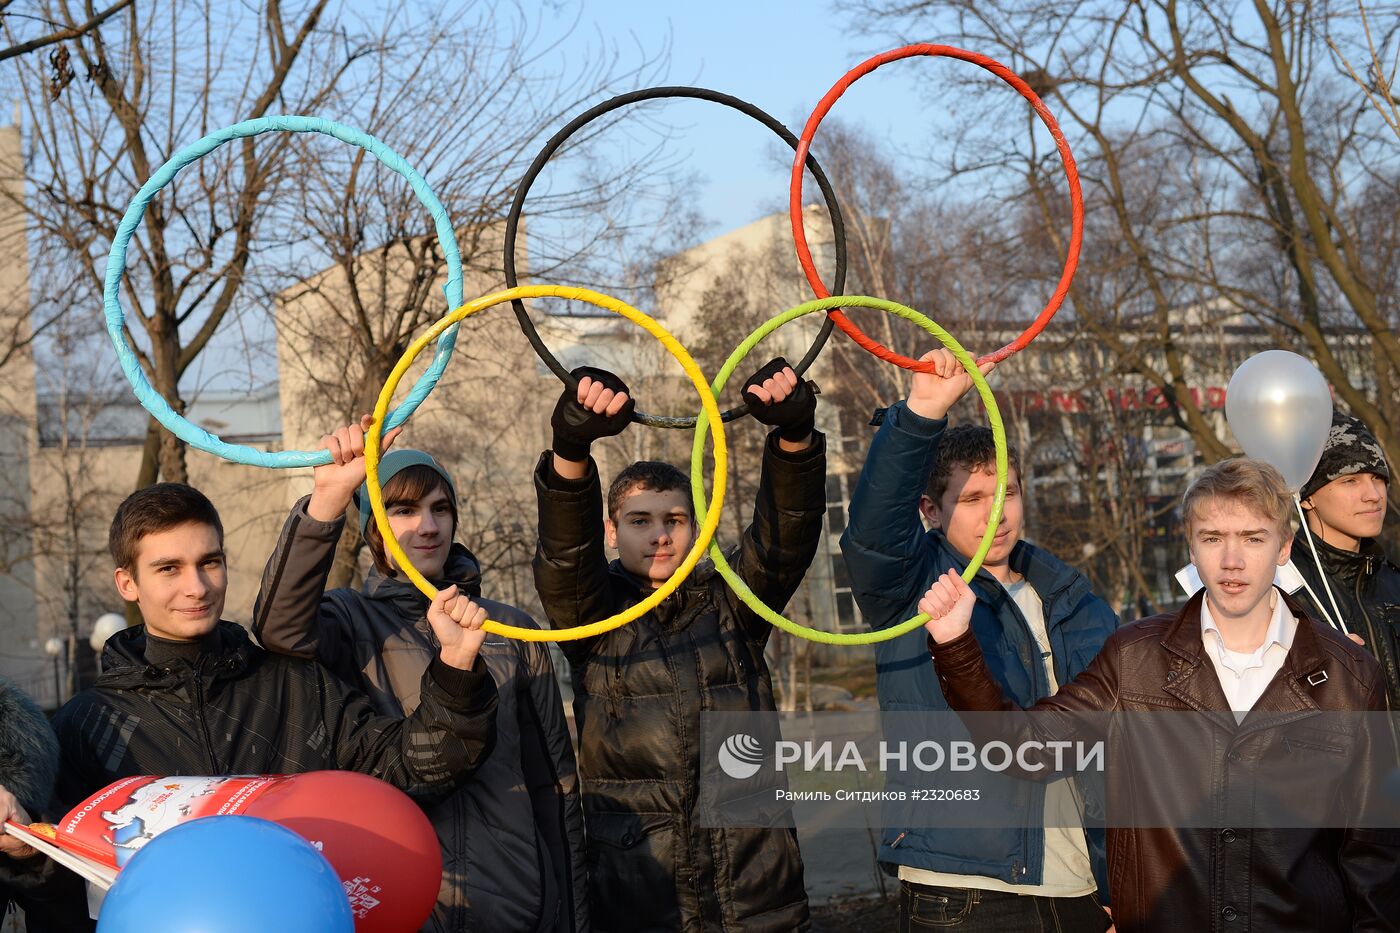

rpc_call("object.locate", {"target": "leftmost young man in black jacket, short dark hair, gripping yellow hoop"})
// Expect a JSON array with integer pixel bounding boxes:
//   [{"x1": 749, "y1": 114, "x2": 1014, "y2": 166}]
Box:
[{"x1": 0, "y1": 483, "x2": 496, "y2": 929}]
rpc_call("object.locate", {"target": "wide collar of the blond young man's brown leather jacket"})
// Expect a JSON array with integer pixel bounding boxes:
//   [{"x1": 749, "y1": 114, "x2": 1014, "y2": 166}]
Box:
[{"x1": 1162, "y1": 590, "x2": 1327, "y2": 731}]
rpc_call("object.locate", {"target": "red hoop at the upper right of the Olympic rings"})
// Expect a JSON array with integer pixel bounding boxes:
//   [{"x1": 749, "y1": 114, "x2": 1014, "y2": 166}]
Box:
[{"x1": 788, "y1": 45, "x2": 1084, "y2": 373}]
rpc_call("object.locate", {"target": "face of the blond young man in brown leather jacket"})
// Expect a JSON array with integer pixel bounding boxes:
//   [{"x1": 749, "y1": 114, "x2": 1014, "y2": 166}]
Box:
[{"x1": 1186, "y1": 499, "x2": 1292, "y2": 619}]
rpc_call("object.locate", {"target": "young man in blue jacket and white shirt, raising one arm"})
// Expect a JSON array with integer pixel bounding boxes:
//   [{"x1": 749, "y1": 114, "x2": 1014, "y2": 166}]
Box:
[{"x1": 841, "y1": 350, "x2": 1117, "y2": 933}]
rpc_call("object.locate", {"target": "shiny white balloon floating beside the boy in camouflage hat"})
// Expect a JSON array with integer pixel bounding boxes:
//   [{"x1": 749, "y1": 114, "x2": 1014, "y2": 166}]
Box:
[{"x1": 1225, "y1": 350, "x2": 1331, "y2": 492}]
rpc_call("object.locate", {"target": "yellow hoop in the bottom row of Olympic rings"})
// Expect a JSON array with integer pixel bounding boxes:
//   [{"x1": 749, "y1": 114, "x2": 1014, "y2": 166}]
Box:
[{"x1": 364, "y1": 286, "x2": 728, "y2": 642}]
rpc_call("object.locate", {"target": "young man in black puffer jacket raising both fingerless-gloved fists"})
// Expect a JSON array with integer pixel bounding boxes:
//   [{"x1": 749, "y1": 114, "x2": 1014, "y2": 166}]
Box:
[{"x1": 535, "y1": 360, "x2": 826, "y2": 933}]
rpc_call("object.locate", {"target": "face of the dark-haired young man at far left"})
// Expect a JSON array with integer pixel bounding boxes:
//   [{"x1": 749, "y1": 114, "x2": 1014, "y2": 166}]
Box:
[{"x1": 115, "y1": 521, "x2": 228, "y2": 642}]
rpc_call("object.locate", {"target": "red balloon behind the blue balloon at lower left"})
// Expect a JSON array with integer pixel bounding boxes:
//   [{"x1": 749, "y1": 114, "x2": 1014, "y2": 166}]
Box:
[{"x1": 244, "y1": 770, "x2": 442, "y2": 933}]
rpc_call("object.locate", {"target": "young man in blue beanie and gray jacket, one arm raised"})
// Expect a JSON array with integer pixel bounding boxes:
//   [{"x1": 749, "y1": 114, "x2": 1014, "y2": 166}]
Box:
[{"x1": 253, "y1": 416, "x2": 588, "y2": 933}]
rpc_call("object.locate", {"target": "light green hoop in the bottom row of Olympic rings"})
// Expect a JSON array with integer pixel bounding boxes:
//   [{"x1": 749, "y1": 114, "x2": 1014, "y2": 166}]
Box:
[{"x1": 688, "y1": 296, "x2": 1008, "y2": 644}]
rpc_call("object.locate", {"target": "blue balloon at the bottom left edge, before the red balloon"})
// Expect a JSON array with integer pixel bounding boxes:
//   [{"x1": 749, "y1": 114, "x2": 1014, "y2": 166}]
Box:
[{"x1": 97, "y1": 817, "x2": 354, "y2": 933}]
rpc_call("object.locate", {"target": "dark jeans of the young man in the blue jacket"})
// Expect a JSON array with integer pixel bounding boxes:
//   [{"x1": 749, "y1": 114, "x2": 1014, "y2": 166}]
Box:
[{"x1": 899, "y1": 881, "x2": 1112, "y2": 933}]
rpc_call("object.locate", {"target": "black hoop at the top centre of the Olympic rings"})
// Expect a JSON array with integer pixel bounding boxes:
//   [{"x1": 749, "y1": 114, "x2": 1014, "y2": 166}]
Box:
[{"x1": 504, "y1": 87, "x2": 846, "y2": 427}]
